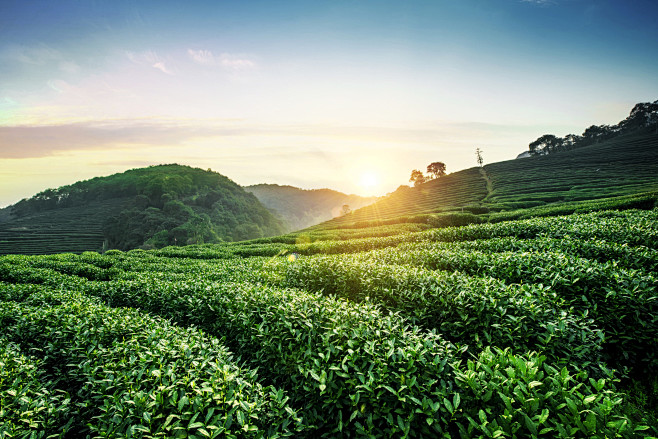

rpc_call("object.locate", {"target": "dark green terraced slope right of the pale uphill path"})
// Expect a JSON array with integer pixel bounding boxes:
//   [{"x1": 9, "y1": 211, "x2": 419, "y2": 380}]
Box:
[{"x1": 482, "y1": 134, "x2": 658, "y2": 208}]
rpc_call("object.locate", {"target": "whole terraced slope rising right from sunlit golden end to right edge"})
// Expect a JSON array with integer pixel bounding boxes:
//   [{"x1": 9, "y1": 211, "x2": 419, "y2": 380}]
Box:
[{"x1": 311, "y1": 131, "x2": 658, "y2": 231}]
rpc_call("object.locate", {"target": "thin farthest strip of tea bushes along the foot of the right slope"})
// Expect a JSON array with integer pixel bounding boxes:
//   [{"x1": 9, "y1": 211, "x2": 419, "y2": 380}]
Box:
[{"x1": 65, "y1": 209, "x2": 658, "y2": 262}]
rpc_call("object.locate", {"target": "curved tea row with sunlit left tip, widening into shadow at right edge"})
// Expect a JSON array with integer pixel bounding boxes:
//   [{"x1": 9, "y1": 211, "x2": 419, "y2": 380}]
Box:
[{"x1": 363, "y1": 243, "x2": 658, "y2": 371}]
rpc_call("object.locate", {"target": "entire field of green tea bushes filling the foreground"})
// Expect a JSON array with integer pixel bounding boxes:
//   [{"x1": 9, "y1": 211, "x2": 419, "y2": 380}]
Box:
[{"x1": 0, "y1": 209, "x2": 658, "y2": 438}]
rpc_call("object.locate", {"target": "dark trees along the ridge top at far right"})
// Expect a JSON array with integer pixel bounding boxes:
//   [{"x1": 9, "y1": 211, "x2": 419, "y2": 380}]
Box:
[{"x1": 528, "y1": 100, "x2": 658, "y2": 156}]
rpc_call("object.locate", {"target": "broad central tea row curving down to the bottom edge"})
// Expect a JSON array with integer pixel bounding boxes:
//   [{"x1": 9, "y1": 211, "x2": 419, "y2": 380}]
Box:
[{"x1": 82, "y1": 277, "x2": 455, "y2": 437}]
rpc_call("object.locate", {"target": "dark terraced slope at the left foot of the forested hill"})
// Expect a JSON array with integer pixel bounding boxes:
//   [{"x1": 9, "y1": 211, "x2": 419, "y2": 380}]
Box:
[{"x1": 0, "y1": 198, "x2": 130, "y2": 255}]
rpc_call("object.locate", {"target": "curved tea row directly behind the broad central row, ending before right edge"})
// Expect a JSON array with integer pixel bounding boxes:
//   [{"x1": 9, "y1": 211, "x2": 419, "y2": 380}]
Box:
[{"x1": 270, "y1": 255, "x2": 603, "y2": 367}]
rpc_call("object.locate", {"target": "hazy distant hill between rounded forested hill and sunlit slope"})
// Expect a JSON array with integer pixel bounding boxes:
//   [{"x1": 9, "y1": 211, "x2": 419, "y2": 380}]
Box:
[{"x1": 245, "y1": 184, "x2": 379, "y2": 232}]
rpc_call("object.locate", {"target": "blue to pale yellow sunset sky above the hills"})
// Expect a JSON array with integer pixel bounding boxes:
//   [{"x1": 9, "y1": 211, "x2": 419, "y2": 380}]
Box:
[{"x1": 0, "y1": 0, "x2": 658, "y2": 207}]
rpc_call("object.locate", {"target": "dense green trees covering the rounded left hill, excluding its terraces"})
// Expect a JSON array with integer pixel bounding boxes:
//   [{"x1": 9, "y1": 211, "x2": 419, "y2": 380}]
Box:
[{"x1": 12, "y1": 164, "x2": 284, "y2": 250}]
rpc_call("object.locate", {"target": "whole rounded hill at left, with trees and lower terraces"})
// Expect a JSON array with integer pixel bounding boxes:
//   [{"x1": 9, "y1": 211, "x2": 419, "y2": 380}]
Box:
[{"x1": 0, "y1": 164, "x2": 284, "y2": 253}]
